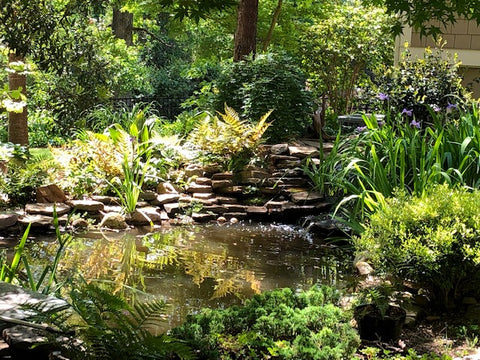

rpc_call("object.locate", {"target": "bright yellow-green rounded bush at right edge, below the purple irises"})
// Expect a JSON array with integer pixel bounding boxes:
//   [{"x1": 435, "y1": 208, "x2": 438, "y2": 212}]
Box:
[{"x1": 354, "y1": 185, "x2": 480, "y2": 307}]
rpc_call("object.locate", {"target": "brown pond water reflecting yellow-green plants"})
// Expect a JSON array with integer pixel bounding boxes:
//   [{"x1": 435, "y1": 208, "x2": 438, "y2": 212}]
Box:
[{"x1": 22, "y1": 224, "x2": 351, "y2": 329}]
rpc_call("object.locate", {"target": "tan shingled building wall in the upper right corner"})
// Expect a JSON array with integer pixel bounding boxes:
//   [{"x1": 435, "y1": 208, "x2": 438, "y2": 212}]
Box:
[{"x1": 395, "y1": 19, "x2": 480, "y2": 98}]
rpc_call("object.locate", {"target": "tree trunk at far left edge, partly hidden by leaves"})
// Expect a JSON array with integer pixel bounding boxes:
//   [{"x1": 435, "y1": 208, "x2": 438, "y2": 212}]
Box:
[{"x1": 8, "y1": 53, "x2": 28, "y2": 145}]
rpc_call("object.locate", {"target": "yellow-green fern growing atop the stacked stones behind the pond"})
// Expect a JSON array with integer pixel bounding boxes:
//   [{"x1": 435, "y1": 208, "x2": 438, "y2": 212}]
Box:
[{"x1": 189, "y1": 105, "x2": 270, "y2": 170}]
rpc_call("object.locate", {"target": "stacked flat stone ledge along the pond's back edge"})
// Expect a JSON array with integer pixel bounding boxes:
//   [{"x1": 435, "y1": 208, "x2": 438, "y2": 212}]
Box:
[{"x1": 0, "y1": 139, "x2": 330, "y2": 231}]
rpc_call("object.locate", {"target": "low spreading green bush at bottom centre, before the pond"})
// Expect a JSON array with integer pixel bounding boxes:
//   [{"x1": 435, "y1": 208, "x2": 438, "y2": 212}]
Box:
[{"x1": 172, "y1": 286, "x2": 359, "y2": 360}]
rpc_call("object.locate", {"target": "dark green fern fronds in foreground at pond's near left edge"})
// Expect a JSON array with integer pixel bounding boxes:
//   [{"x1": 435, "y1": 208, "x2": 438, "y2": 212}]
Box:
[{"x1": 58, "y1": 283, "x2": 193, "y2": 360}]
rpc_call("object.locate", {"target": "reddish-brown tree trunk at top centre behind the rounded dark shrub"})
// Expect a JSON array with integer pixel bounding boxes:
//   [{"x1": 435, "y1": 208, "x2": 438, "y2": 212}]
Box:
[{"x1": 233, "y1": 0, "x2": 258, "y2": 61}]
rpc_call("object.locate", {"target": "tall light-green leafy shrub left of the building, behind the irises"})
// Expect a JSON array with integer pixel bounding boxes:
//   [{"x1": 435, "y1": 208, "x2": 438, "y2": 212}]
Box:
[{"x1": 300, "y1": 3, "x2": 393, "y2": 114}]
